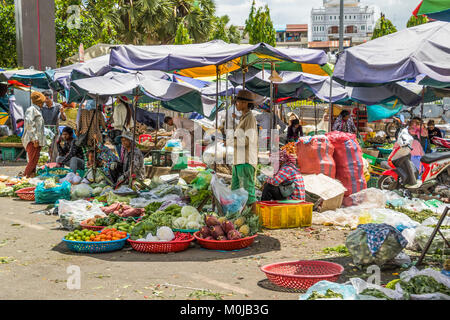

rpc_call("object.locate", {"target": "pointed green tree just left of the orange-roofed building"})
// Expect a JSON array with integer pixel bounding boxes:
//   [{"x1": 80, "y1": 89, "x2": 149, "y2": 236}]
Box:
[{"x1": 244, "y1": 0, "x2": 276, "y2": 47}]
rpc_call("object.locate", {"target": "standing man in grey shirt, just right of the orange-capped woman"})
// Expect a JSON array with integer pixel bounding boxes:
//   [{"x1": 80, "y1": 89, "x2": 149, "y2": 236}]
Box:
[{"x1": 41, "y1": 90, "x2": 66, "y2": 162}]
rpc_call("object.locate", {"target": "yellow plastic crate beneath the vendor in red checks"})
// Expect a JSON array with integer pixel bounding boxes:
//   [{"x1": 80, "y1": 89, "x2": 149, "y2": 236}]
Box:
[{"x1": 256, "y1": 201, "x2": 314, "y2": 229}]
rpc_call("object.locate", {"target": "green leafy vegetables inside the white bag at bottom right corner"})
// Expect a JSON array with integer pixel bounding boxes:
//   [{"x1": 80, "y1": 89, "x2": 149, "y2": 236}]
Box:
[{"x1": 399, "y1": 275, "x2": 450, "y2": 299}]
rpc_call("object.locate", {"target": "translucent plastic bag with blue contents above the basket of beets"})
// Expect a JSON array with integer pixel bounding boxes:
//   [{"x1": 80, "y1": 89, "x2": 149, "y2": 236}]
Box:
[{"x1": 211, "y1": 174, "x2": 248, "y2": 214}]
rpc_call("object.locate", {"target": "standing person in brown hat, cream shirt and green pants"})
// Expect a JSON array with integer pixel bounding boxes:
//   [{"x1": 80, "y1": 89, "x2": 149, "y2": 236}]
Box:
[{"x1": 231, "y1": 90, "x2": 258, "y2": 213}]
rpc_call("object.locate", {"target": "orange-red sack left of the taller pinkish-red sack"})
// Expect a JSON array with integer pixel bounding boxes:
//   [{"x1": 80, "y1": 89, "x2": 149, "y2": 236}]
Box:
[{"x1": 297, "y1": 135, "x2": 336, "y2": 179}]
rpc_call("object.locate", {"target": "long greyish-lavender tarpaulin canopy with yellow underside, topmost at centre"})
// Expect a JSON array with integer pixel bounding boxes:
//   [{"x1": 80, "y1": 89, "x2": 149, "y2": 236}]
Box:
[{"x1": 109, "y1": 40, "x2": 327, "y2": 77}]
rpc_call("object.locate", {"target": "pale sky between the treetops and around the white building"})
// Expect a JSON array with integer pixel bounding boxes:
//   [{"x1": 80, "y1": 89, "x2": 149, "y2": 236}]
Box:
[{"x1": 216, "y1": 0, "x2": 420, "y2": 30}]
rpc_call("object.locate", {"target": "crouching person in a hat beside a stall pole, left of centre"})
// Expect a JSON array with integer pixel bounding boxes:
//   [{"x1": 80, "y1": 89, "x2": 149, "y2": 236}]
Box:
[{"x1": 118, "y1": 131, "x2": 145, "y2": 185}]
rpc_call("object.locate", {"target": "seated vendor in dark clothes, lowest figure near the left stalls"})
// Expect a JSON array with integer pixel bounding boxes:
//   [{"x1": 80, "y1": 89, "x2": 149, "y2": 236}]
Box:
[{"x1": 56, "y1": 127, "x2": 84, "y2": 173}]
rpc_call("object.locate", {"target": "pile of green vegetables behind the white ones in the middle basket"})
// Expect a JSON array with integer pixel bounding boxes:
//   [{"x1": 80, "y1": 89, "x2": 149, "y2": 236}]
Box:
[{"x1": 130, "y1": 204, "x2": 181, "y2": 240}]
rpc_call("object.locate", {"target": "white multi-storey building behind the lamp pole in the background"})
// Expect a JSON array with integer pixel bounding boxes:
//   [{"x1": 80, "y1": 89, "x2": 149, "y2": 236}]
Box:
[{"x1": 309, "y1": 0, "x2": 376, "y2": 47}]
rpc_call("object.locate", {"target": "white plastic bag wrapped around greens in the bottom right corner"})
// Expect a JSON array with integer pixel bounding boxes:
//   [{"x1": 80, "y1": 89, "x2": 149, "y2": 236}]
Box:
[{"x1": 395, "y1": 267, "x2": 450, "y2": 300}]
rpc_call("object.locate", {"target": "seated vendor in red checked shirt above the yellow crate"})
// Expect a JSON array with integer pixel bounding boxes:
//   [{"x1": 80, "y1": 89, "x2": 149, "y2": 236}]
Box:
[{"x1": 261, "y1": 150, "x2": 305, "y2": 201}]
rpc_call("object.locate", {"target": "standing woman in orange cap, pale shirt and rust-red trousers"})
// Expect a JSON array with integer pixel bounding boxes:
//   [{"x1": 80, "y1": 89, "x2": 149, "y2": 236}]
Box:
[{"x1": 22, "y1": 92, "x2": 45, "y2": 178}]
